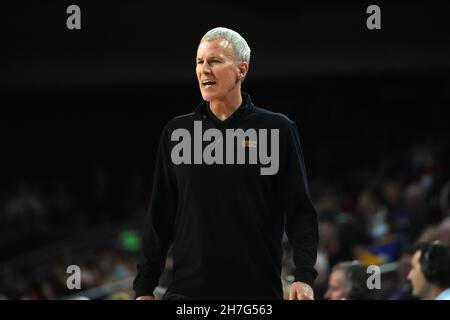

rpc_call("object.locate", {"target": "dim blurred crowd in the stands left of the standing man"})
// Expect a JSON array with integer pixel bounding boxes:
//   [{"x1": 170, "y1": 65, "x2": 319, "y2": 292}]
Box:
[{"x1": 0, "y1": 166, "x2": 151, "y2": 299}]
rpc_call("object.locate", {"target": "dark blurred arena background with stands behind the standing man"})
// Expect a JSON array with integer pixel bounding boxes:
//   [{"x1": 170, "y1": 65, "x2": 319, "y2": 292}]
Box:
[{"x1": 0, "y1": 0, "x2": 450, "y2": 299}]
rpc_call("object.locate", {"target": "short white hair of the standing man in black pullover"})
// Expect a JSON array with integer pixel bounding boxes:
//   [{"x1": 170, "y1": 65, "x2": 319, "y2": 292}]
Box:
[{"x1": 201, "y1": 27, "x2": 250, "y2": 63}]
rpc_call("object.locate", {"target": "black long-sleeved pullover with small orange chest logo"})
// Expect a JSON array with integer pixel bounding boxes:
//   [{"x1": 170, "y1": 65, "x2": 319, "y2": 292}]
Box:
[{"x1": 134, "y1": 93, "x2": 318, "y2": 299}]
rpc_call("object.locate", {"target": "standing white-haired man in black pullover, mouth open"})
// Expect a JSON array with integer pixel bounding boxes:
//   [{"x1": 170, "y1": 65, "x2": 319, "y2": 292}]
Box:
[{"x1": 134, "y1": 28, "x2": 318, "y2": 300}]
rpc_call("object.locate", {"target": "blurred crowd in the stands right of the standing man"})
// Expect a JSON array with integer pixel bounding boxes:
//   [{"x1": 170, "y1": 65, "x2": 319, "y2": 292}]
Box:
[{"x1": 312, "y1": 143, "x2": 450, "y2": 299}]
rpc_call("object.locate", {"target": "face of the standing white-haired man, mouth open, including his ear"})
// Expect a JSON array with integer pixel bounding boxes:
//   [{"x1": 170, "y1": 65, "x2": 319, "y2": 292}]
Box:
[{"x1": 196, "y1": 39, "x2": 248, "y2": 101}]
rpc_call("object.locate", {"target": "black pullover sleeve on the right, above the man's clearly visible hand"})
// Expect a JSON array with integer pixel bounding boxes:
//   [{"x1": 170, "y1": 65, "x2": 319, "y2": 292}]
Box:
[{"x1": 278, "y1": 121, "x2": 319, "y2": 286}]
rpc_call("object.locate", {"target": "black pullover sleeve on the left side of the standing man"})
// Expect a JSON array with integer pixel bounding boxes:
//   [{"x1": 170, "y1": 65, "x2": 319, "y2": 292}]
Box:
[{"x1": 133, "y1": 127, "x2": 178, "y2": 297}]
